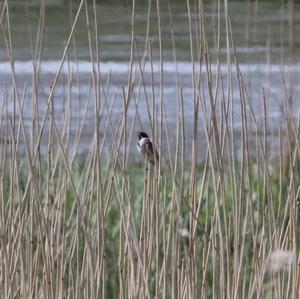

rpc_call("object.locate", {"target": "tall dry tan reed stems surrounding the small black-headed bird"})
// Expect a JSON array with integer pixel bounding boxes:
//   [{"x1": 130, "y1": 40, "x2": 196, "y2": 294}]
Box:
[{"x1": 0, "y1": 0, "x2": 300, "y2": 298}]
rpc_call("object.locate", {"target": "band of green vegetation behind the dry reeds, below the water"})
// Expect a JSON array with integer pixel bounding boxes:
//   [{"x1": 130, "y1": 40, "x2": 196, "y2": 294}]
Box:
[{"x1": 1, "y1": 154, "x2": 300, "y2": 298}]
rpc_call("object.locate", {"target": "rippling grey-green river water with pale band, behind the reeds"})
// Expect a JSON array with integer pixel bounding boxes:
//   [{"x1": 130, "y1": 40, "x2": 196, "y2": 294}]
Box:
[{"x1": 0, "y1": 1, "x2": 300, "y2": 159}]
